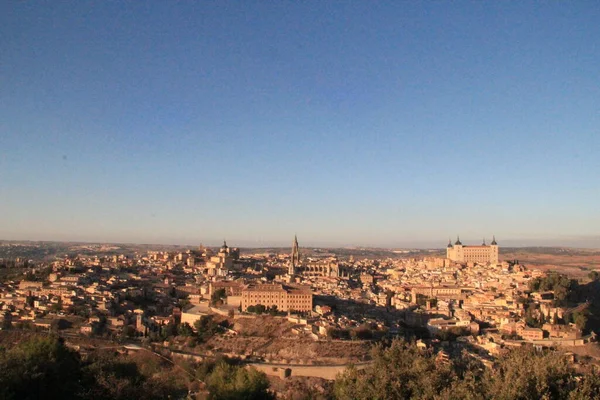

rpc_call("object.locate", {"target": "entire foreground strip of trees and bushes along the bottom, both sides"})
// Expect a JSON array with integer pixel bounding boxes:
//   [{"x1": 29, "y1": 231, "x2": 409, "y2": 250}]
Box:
[{"x1": 0, "y1": 337, "x2": 600, "y2": 400}]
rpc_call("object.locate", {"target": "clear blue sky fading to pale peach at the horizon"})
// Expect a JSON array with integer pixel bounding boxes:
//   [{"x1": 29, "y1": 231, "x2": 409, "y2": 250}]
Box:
[{"x1": 0, "y1": 1, "x2": 600, "y2": 248}]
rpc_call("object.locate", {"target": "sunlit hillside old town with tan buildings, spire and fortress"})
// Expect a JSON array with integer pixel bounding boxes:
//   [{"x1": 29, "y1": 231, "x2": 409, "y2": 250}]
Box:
[{"x1": 0, "y1": 235, "x2": 600, "y2": 398}]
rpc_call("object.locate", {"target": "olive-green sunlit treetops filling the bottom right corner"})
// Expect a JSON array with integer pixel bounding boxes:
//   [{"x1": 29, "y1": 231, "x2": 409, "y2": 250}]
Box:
[{"x1": 334, "y1": 340, "x2": 600, "y2": 400}]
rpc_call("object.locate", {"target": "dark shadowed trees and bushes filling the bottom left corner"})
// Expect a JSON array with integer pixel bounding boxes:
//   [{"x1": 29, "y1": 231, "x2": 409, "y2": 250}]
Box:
[{"x1": 0, "y1": 337, "x2": 272, "y2": 400}]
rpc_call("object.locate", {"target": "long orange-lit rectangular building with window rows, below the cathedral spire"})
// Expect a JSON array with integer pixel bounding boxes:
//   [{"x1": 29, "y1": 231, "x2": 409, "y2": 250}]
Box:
[{"x1": 242, "y1": 284, "x2": 312, "y2": 311}]
